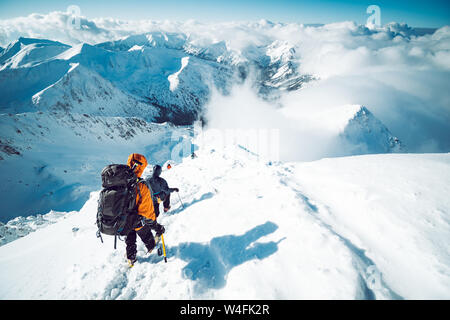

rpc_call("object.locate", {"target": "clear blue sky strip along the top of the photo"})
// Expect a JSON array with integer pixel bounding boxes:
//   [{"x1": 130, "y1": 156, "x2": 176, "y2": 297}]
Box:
[{"x1": 0, "y1": 0, "x2": 450, "y2": 27}]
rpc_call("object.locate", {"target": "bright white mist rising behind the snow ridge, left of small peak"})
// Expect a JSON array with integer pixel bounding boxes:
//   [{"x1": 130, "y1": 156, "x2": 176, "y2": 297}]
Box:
[{"x1": 205, "y1": 81, "x2": 356, "y2": 161}]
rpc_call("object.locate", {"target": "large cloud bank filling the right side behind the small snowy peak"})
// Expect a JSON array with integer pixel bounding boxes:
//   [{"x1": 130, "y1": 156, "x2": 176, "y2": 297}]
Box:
[{"x1": 282, "y1": 26, "x2": 450, "y2": 152}]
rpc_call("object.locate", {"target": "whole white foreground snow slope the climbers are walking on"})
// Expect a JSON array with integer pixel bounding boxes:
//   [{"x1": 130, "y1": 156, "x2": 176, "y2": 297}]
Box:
[{"x1": 0, "y1": 142, "x2": 450, "y2": 299}]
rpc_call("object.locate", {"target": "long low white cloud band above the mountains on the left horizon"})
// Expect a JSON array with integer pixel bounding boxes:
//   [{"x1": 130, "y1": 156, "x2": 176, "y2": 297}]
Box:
[{"x1": 0, "y1": 11, "x2": 266, "y2": 48}]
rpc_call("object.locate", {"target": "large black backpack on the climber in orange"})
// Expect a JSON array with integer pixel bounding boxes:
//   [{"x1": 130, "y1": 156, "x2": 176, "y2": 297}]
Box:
[{"x1": 97, "y1": 164, "x2": 141, "y2": 249}]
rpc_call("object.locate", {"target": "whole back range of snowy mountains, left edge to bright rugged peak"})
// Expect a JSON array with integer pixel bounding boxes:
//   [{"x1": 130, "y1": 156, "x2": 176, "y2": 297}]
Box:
[{"x1": 0, "y1": 32, "x2": 312, "y2": 114}]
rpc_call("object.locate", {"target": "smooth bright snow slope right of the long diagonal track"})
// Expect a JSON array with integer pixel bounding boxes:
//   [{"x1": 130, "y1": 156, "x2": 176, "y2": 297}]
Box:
[{"x1": 286, "y1": 153, "x2": 450, "y2": 299}]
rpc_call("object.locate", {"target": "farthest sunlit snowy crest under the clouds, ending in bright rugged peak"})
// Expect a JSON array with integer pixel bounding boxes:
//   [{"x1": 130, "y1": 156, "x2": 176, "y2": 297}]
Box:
[{"x1": 98, "y1": 32, "x2": 313, "y2": 95}]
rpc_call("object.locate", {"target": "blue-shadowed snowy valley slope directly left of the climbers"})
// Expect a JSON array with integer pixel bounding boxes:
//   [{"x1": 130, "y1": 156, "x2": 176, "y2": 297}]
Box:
[{"x1": 0, "y1": 112, "x2": 190, "y2": 222}]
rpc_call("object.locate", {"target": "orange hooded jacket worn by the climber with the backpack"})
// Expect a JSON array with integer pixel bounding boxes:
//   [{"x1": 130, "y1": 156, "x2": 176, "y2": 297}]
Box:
[{"x1": 127, "y1": 153, "x2": 156, "y2": 221}]
